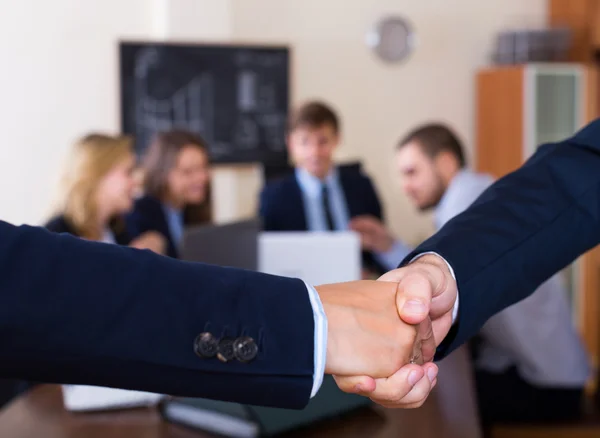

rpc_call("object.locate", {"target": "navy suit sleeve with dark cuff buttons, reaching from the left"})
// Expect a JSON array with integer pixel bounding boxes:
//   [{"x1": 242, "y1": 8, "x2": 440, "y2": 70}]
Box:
[{"x1": 0, "y1": 222, "x2": 314, "y2": 408}]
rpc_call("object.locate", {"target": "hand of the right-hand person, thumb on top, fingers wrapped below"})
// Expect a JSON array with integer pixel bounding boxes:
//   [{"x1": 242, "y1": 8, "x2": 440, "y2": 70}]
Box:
[{"x1": 336, "y1": 255, "x2": 457, "y2": 408}]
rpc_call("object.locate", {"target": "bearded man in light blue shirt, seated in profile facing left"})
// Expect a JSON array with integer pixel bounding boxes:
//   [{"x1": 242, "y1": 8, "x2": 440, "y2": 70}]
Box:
[{"x1": 351, "y1": 124, "x2": 590, "y2": 427}]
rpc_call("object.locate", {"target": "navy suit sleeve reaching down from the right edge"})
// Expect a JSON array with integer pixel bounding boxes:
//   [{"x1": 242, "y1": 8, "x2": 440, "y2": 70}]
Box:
[{"x1": 403, "y1": 127, "x2": 600, "y2": 357}]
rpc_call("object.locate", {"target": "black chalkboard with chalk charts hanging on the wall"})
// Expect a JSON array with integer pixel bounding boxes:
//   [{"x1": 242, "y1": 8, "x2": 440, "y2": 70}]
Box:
[{"x1": 119, "y1": 42, "x2": 290, "y2": 164}]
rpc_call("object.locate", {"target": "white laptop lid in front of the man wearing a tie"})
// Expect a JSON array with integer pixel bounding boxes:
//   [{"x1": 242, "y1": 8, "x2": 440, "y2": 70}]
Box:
[{"x1": 258, "y1": 231, "x2": 362, "y2": 285}]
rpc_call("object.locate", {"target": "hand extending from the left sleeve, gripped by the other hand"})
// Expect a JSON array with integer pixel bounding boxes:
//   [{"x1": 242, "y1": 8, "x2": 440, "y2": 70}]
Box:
[{"x1": 316, "y1": 280, "x2": 435, "y2": 380}]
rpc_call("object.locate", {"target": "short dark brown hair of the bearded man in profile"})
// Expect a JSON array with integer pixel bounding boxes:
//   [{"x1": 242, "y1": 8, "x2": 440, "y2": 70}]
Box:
[{"x1": 398, "y1": 123, "x2": 467, "y2": 167}]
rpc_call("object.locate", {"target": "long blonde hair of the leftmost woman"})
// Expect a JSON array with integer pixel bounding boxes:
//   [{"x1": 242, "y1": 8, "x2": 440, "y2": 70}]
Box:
[{"x1": 59, "y1": 133, "x2": 133, "y2": 240}]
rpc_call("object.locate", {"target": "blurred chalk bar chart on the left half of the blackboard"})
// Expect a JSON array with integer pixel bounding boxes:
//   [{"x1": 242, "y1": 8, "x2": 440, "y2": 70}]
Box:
[{"x1": 134, "y1": 48, "x2": 214, "y2": 144}]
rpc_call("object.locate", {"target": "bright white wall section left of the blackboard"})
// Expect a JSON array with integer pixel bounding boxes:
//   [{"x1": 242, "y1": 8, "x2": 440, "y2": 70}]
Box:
[{"x1": 0, "y1": 0, "x2": 153, "y2": 223}]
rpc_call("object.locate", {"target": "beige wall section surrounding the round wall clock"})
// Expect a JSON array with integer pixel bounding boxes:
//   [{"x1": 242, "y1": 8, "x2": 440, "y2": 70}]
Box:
[{"x1": 233, "y1": 0, "x2": 546, "y2": 241}]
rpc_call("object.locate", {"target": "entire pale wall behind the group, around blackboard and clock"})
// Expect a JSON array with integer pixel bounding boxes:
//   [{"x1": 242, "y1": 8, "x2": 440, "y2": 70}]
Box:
[{"x1": 0, "y1": 0, "x2": 546, "y2": 240}]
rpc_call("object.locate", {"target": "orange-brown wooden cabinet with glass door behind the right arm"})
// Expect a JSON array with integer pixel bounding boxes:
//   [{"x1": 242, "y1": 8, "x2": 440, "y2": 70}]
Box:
[{"x1": 476, "y1": 64, "x2": 600, "y2": 386}]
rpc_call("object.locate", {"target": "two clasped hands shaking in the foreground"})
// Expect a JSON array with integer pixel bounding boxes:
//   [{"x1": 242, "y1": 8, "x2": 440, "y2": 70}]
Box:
[{"x1": 316, "y1": 255, "x2": 457, "y2": 408}]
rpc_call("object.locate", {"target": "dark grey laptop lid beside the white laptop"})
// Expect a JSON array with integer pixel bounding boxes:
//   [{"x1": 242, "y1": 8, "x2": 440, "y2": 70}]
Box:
[{"x1": 180, "y1": 218, "x2": 262, "y2": 271}]
